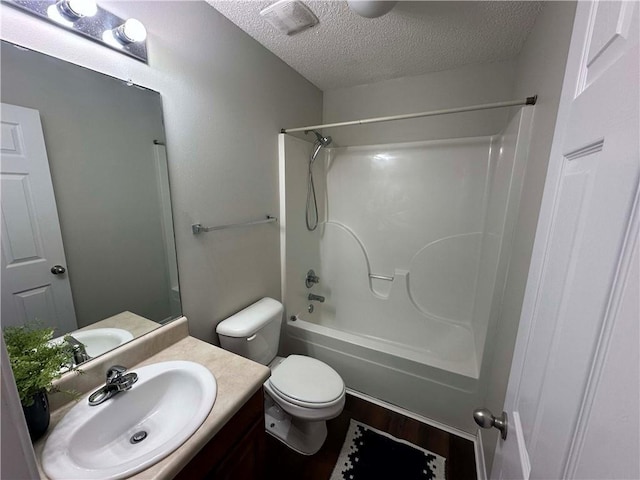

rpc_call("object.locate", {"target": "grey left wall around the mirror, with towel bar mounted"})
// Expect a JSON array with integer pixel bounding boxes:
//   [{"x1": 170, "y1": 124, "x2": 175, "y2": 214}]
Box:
[{"x1": 0, "y1": 1, "x2": 322, "y2": 340}]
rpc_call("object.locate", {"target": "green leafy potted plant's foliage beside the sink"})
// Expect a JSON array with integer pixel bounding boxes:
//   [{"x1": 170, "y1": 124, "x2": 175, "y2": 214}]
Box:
[{"x1": 3, "y1": 323, "x2": 80, "y2": 407}]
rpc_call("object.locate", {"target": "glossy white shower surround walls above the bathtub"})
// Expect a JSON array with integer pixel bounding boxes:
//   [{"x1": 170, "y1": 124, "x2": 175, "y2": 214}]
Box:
[{"x1": 284, "y1": 137, "x2": 491, "y2": 377}]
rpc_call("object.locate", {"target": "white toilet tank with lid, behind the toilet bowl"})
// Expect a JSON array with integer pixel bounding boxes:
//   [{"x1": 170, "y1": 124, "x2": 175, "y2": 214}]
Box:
[{"x1": 216, "y1": 297, "x2": 284, "y2": 365}]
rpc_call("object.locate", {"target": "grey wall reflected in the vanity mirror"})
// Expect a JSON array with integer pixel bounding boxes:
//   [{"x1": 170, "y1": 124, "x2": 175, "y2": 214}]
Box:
[{"x1": 0, "y1": 44, "x2": 171, "y2": 328}]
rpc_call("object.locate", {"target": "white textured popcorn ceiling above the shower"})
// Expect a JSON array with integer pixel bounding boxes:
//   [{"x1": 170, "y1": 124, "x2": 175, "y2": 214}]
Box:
[{"x1": 207, "y1": 0, "x2": 541, "y2": 90}]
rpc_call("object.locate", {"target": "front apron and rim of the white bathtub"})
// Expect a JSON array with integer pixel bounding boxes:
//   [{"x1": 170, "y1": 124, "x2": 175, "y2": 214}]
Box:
[{"x1": 282, "y1": 316, "x2": 482, "y2": 434}]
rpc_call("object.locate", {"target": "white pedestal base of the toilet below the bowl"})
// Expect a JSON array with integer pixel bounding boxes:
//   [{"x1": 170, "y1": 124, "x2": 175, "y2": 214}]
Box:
[{"x1": 264, "y1": 396, "x2": 327, "y2": 455}]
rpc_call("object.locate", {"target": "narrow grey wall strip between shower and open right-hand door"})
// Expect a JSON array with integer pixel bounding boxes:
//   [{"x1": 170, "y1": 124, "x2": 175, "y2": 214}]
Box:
[{"x1": 482, "y1": 2, "x2": 575, "y2": 471}]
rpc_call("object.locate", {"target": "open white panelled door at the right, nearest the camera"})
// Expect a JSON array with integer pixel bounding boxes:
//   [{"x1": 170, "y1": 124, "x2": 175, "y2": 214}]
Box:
[{"x1": 491, "y1": 1, "x2": 640, "y2": 479}]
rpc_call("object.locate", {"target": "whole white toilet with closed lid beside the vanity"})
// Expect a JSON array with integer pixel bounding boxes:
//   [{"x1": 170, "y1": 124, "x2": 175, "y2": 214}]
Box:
[{"x1": 216, "y1": 298, "x2": 345, "y2": 455}]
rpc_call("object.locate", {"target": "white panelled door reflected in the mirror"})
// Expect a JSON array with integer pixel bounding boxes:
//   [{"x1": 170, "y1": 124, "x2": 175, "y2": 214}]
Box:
[{"x1": 0, "y1": 103, "x2": 77, "y2": 334}]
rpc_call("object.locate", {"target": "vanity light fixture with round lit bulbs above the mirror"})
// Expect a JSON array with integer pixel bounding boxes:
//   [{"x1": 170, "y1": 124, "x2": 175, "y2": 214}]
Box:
[{"x1": 1, "y1": 0, "x2": 147, "y2": 63}]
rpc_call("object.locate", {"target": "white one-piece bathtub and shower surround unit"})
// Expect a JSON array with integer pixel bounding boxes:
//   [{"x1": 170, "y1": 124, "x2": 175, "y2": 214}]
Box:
[{"x1": 280, "y1": 109, "x2": 531, "y2": 430}]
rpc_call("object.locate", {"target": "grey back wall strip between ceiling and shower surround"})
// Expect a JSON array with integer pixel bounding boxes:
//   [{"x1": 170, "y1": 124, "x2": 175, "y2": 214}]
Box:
[{"x1": 323, "y1": 62, "x2": 516, "y2": 147}]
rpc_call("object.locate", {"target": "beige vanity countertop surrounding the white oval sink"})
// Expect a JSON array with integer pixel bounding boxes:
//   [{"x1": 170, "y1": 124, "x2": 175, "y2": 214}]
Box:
[{"x1": 34, "y1": 337, "x2": 270, "y2": 480}]
